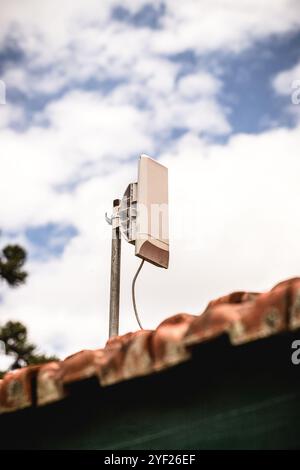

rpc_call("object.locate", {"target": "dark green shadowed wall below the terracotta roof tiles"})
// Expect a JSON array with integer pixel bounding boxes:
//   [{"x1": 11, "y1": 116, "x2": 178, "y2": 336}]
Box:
[{"x1": 0, "y1": 333, "x2": 300, "y2": 450}]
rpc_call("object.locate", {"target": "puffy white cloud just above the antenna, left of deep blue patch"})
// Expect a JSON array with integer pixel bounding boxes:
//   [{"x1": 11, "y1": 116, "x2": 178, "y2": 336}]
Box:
[{"x1": 110, "y1": 66, "x2": 231, "y2": 135}]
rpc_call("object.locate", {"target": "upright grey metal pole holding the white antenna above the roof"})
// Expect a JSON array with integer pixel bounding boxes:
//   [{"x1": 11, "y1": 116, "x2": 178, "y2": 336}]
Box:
[{"x1": 109, "y1": 199, "x2": 121, "y2": 338}]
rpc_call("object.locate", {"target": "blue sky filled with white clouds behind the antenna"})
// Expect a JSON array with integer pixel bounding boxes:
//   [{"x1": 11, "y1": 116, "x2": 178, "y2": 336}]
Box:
[{"x1": 0, "y1": 0, "x2": 300, "y2": 357}]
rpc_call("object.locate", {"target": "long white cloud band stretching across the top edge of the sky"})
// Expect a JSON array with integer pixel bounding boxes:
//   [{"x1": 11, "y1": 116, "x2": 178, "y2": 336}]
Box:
[{"x1": 0, "y1": 0, "x2": 300, "y2": 98}]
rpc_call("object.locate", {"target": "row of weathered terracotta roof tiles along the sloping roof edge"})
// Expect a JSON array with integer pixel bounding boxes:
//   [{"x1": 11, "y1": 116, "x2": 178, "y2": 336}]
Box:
[{"x1": 0, "y1": 278, "x2": 300, "y2": 413}]
